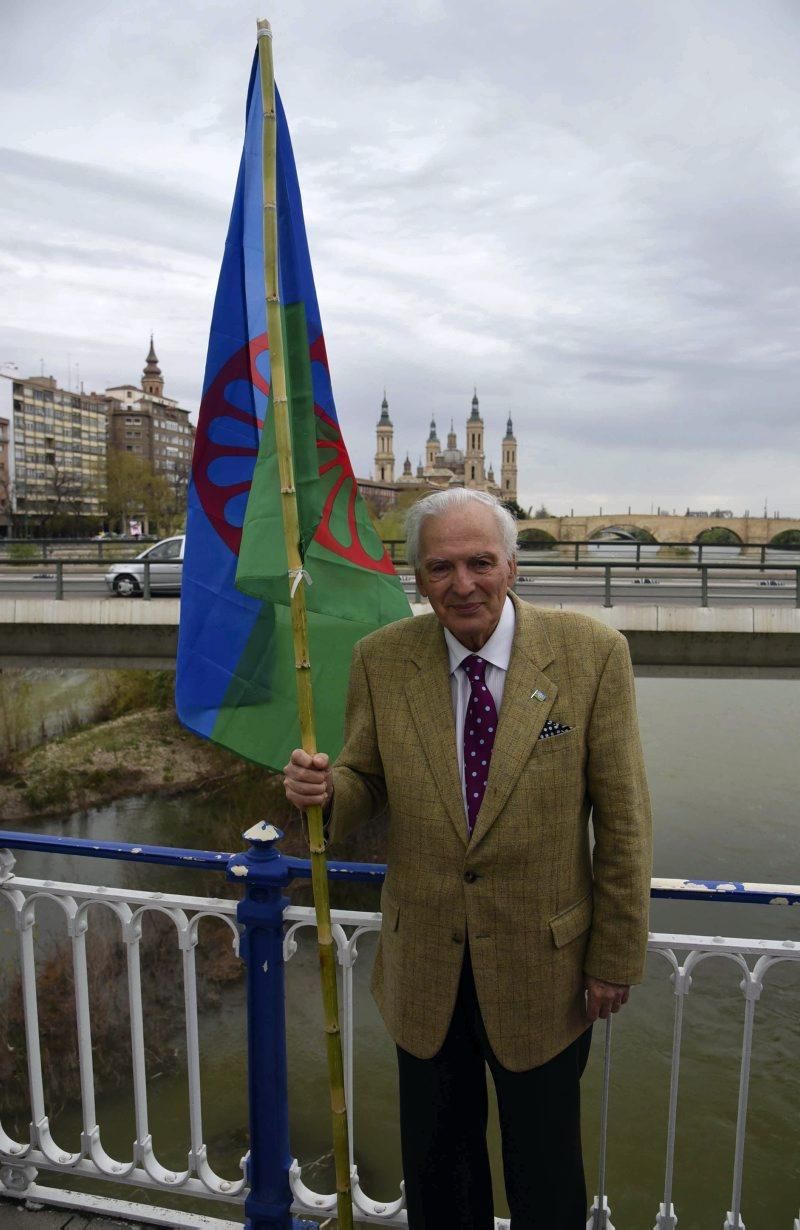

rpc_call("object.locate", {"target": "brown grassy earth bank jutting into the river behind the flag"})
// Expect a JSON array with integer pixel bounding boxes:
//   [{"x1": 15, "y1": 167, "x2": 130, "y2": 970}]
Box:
[{"x1": 0, "y1": 706, "x2": 251, "y2": 825}]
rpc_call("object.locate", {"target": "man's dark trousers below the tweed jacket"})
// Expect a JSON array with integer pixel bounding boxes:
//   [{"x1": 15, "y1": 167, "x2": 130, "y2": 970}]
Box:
[{"x1": 398, "y1": 951, "x2": 592, "y2": 1230}]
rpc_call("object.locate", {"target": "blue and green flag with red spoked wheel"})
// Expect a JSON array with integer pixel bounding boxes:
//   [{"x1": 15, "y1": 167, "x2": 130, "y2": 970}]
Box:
[{"x1": 176, "y1": 55, "x2": 411, "y2": 770}]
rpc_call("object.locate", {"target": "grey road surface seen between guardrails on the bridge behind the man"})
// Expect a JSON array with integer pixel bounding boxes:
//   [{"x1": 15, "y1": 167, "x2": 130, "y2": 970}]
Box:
[{"x1": 0, "y1": 568, "x2": 795, "y2": 606}]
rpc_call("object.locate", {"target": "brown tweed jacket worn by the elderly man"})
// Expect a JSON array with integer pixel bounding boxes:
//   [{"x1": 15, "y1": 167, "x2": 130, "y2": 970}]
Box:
[{"x1": 330, "y1": 595, "x2": 651, "y2": 1071}]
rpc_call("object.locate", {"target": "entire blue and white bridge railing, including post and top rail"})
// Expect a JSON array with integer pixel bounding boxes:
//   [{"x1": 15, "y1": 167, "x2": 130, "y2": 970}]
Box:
[{"x1": 0, "y1": 824, "x2": 800, "y2": 1230}]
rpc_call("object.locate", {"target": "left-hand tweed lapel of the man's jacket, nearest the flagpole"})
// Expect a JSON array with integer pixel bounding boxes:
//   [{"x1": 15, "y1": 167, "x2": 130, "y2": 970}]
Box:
[{"x1": 406, "y1": 615, "x2": 468, "y2": 846}]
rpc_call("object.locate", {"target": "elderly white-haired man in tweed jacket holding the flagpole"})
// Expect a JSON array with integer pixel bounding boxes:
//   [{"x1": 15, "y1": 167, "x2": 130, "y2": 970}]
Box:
[{"x1": 286, "y1": 490, "x2": 650, "y2": 1230}]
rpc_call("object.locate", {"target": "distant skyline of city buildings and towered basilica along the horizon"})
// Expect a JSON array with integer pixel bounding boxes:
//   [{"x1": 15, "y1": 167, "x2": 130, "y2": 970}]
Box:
[{"x1": 0, "y1": 346, "x2": 782, "y2": 538}]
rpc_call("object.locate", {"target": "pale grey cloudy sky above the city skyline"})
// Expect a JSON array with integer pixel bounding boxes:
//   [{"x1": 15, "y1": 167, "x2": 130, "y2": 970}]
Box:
[{"x1": 0, "y1": 0, "x2": 800, "y2": 515}]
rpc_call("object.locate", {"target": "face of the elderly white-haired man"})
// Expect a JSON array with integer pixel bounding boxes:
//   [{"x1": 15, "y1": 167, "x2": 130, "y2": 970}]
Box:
[{"x1": 416, "y1": 502, "x2": 517, "y2": 652}]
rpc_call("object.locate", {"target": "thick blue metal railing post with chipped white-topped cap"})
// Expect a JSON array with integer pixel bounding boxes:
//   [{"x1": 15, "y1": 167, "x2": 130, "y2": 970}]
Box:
[{"x1": 226, "y1": 823, "x2": 316, "y2": 1230}]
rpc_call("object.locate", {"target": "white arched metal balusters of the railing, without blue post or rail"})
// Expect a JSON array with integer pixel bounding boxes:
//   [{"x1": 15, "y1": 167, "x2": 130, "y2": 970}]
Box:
[{"x1": 0, "y1": 851, "x2": 800, "y2": 1230}]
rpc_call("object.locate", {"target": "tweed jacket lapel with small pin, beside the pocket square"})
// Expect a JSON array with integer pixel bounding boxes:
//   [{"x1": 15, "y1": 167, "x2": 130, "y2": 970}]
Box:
[{"x1": 467, "y1": 594, "x2": 558, "y2": 845}]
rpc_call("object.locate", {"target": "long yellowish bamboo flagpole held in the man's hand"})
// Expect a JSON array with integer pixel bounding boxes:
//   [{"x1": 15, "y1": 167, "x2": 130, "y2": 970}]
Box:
[{"x1": 257, "y1": 18, "x2": 353, "y2": 1230}]
